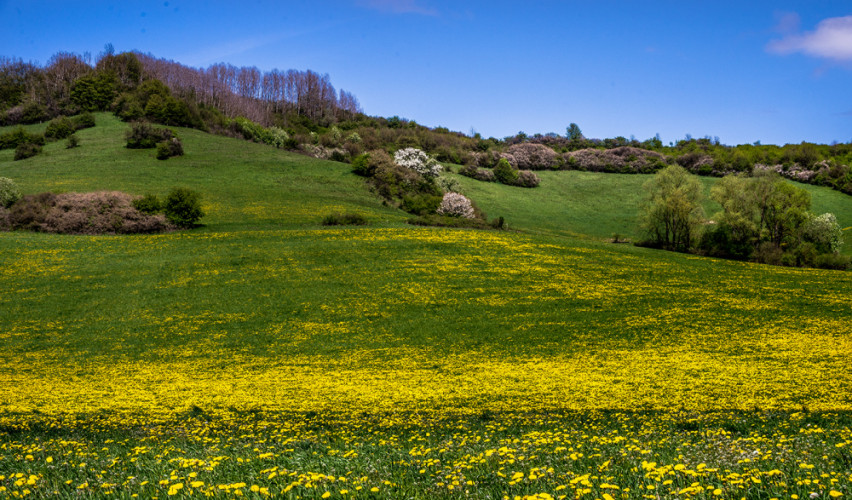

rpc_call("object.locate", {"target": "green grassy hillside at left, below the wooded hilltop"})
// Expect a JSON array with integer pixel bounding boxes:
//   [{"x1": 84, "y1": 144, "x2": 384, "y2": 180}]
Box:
[{"x1": 0, "y1": 113, "x2": 412, "y2": 230}]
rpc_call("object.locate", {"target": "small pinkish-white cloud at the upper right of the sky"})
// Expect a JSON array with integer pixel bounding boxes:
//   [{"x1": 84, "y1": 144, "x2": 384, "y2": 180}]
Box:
[{"x1": 766, "y1": 16, "x2": 852, "y2": 62}]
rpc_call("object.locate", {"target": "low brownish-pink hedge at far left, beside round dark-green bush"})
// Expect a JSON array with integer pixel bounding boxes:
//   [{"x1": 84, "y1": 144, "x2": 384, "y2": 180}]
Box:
[{"x1": 8, "y1": 191, "x2": 170, "y2": 234}]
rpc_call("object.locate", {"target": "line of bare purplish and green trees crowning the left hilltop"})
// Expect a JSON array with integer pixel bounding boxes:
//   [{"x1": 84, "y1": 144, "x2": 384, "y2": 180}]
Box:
[{"x1": 0, "y1": 46, "x2": 362, "y2": 126}]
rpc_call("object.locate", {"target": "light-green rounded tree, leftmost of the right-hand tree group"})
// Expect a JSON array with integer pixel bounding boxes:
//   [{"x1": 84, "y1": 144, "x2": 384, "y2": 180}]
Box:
[{"x1": 640, "y1": 165, "x2": 704, "y2": 252}]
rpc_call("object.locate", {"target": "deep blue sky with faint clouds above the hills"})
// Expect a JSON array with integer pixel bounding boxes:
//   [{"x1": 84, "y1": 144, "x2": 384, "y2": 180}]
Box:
[{"x1": 0, "y1": 0, "x2": 852, "y2": 144}]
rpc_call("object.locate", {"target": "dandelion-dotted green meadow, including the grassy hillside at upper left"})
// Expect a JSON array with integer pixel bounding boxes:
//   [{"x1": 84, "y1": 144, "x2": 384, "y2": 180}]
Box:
[{"x1": 0, "y1": 115, "x2": 852, "y2": 500}]
